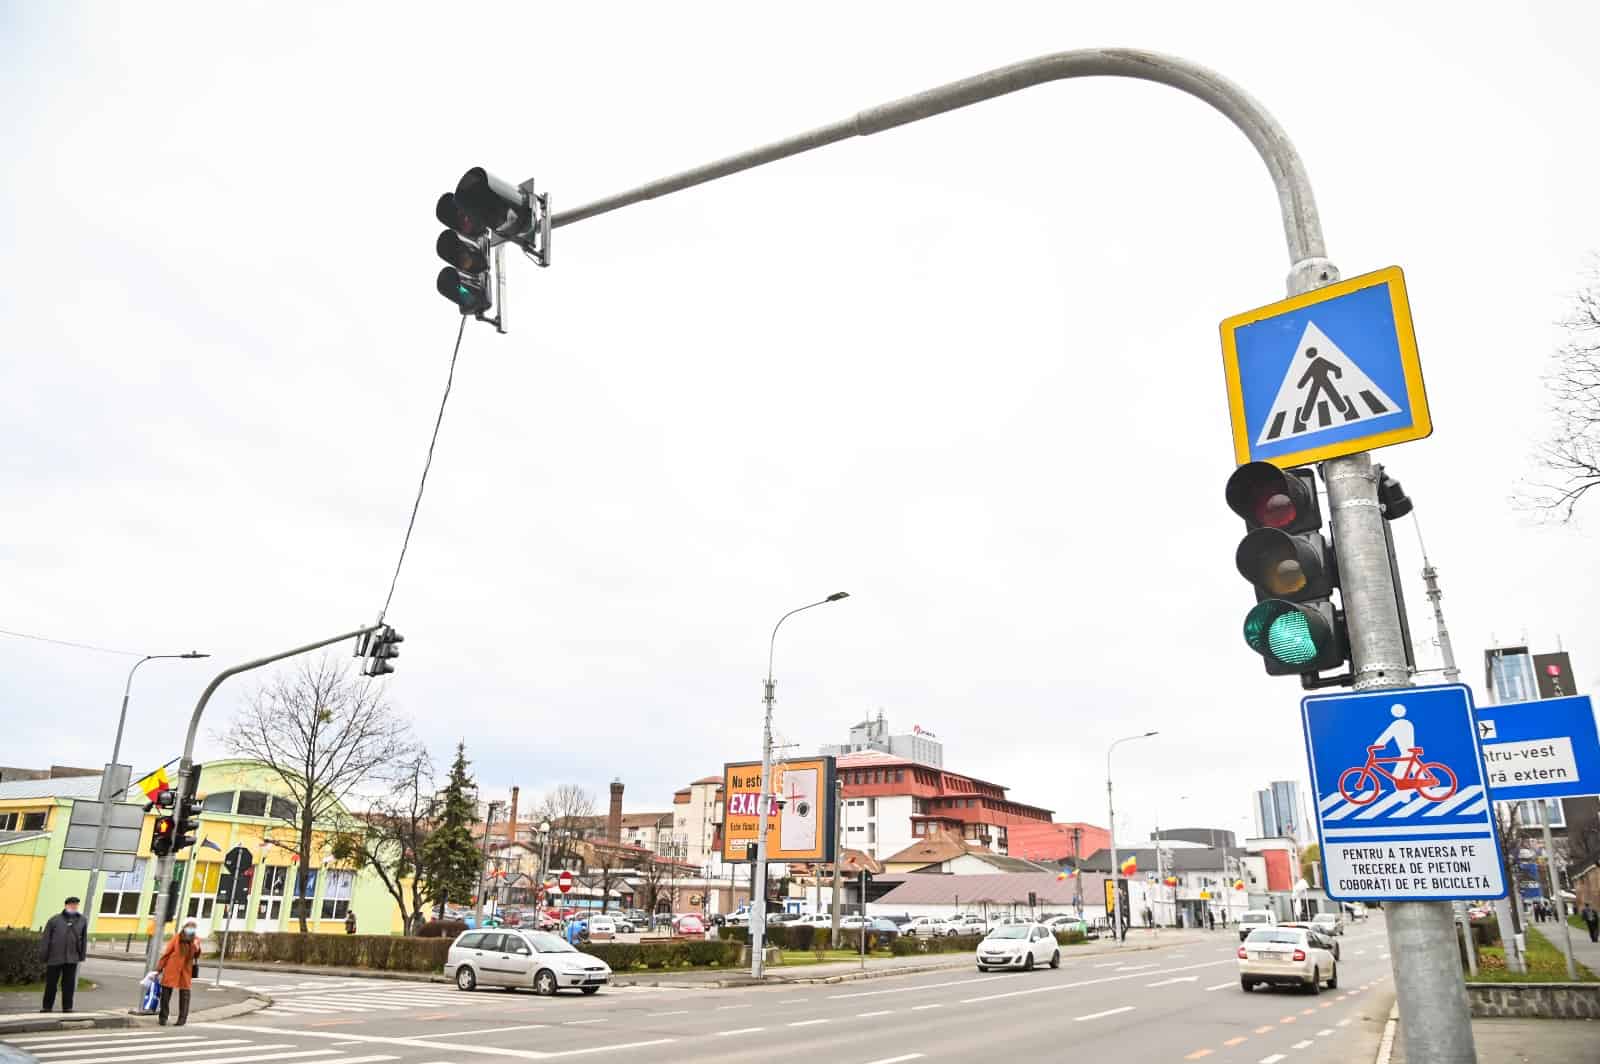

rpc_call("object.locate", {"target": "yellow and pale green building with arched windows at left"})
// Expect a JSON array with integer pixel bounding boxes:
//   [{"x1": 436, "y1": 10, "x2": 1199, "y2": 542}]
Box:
[{"x1": 0, "y1": 760, "x2": 419, "y2": 934}]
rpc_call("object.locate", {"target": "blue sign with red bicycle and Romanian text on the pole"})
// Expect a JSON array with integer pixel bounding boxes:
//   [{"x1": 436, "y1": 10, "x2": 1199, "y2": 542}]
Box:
[{"x1": 1301, "y1": 683, "x2": 1506, "y2": 901}]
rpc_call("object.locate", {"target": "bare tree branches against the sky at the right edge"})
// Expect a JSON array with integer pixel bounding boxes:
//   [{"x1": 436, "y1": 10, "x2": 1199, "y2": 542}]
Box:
[{"x1": 1517, "y1": 256, "x2": 1600, "y2": 522}]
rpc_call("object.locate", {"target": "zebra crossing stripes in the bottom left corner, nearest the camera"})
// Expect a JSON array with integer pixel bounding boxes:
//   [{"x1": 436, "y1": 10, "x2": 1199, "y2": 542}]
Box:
[{"x1": 6, "y1": 1027, "x2": 400, "y2": 1064}]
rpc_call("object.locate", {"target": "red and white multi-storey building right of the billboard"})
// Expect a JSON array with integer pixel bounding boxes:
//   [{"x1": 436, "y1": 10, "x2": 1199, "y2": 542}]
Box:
[{"x1": 837, "y1": 750, "x2": 1051, "y2": 858}]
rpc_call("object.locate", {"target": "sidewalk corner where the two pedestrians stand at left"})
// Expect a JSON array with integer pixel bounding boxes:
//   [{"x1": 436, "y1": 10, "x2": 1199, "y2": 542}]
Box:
[{"x1": 0, "y1": 957, "x2": 269, "y2": 1038}]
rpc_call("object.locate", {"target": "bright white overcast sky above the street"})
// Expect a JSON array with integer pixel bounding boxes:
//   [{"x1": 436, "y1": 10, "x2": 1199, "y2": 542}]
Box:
[{"x1": 0, "y1": 0, "x2": 1600, "y2": 835}]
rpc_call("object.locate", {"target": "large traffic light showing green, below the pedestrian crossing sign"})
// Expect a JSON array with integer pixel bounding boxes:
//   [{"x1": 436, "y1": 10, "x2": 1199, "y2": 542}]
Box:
[{"x1": 1226, "y1": 462, "x2": 1349, "y2": 685}]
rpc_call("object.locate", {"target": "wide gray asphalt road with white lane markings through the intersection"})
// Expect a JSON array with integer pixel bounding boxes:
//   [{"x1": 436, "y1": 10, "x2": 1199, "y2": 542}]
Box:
[{"x1": 11, "y1": 917, "x2": 1390, "y2": 1064}]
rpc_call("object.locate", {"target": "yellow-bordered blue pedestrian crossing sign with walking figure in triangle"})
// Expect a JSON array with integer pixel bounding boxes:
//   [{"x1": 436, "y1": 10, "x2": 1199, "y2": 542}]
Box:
[{"x1": 1222, "y1": 266, "x2": 1434, "y2": 467}]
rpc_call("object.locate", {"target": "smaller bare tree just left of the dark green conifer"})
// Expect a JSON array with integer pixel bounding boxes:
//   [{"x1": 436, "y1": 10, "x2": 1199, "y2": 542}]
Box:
[{"x1": 333, "y1": 746, "x2": 438, "y2": 933}]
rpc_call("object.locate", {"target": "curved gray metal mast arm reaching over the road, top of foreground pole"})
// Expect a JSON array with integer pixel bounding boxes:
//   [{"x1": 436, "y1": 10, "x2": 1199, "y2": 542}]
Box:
[{"x1": 550, "y1": 48, "x2": 1326, "y2": 264}]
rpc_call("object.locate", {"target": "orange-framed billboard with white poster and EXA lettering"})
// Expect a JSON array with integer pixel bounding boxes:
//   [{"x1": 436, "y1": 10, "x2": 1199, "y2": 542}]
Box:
[{"x1": 722, "y1": 757, "x2": 838, "y2": 862}]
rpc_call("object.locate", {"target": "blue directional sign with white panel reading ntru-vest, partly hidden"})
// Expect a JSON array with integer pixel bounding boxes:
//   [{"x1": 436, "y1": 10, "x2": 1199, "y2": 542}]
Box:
[{"x1": 1478, "y1": 694, "x2": 1600, "y2": 802}]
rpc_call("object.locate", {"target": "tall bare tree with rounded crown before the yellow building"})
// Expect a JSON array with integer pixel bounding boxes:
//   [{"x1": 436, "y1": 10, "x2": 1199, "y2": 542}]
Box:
[{"x1": 221, "y1": 654, "x2": 413, "y2": 933}]
